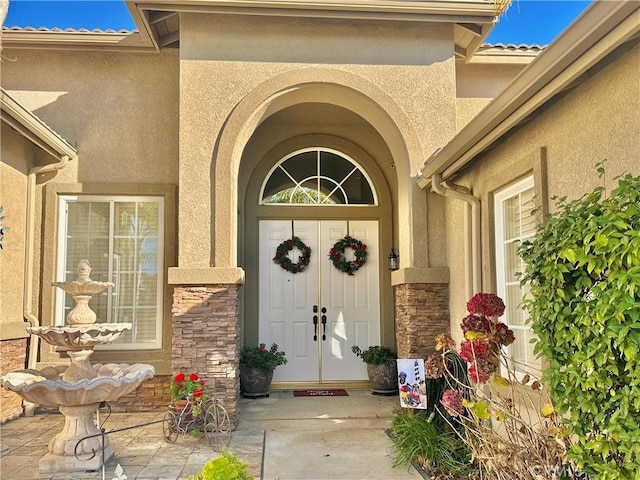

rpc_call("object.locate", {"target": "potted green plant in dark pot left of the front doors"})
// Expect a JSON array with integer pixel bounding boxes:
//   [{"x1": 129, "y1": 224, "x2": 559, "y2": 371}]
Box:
[{"x1": 240, "y1": 343, "x2": 287, "y2": 398}]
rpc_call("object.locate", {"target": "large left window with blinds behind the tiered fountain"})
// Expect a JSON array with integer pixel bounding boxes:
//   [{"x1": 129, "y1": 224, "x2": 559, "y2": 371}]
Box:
[{"x1": 56, "y1": 196, "x2": 164, "y2": 349}]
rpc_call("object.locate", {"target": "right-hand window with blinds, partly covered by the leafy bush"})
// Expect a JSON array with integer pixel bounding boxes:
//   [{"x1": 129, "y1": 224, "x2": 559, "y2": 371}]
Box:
[{"x1": 494, "y1": 177, "x2": 542, "y2": 375}]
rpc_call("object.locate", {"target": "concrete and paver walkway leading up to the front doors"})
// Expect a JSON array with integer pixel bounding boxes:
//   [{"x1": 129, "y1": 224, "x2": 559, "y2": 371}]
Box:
[{"x1": 0, "y1": 390, "x2": 422, "y2": 480}]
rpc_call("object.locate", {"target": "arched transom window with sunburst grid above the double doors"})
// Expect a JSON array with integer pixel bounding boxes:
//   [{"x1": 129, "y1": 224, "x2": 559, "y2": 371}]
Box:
[{"x1": 260, "y1": 147, "x2": 377, "y2": 205}]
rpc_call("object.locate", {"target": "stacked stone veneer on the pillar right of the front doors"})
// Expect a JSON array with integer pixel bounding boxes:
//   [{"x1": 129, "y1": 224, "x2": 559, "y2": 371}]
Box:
[{"x1": 395, "y1": 283, "x2": 451, "y2": 358}]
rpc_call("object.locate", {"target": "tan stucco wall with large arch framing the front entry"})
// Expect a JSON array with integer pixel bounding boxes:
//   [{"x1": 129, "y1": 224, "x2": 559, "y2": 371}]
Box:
[{"x1": 179, "y1": 15, "x2": 456, "y2": 274}]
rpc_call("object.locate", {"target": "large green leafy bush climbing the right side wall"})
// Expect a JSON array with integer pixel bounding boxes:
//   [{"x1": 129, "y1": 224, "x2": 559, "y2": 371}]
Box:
[{"x1": 519, "y1": 168, "x2": 640, "y2": 480}]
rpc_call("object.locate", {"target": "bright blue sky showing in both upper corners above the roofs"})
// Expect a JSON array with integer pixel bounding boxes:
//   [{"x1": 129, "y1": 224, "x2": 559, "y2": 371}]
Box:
[{"x1": 4, "y1": 0, "x2": 591, "y2": 45}]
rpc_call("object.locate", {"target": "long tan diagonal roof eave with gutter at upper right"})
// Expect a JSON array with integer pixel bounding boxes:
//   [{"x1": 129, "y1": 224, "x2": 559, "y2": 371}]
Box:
[{"x1": 417, "y1": 0, "x2": 640, "y2": 188}]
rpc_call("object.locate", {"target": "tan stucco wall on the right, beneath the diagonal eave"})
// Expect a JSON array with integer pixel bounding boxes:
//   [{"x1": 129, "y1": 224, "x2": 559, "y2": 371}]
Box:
[{"x1": 446, "y1": 42, "x2": 640, "y2": 342}]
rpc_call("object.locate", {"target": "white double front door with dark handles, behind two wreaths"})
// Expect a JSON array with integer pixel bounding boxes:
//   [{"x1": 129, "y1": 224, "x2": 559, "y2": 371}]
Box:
[{"x1": 259, "y1": 220, "x2": 380, "y2": 383}]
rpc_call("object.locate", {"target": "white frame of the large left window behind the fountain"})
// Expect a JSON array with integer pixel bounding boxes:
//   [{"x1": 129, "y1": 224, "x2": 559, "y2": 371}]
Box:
[{"x1": 54, "y1": 195, "x2": 164, "y2": 350}]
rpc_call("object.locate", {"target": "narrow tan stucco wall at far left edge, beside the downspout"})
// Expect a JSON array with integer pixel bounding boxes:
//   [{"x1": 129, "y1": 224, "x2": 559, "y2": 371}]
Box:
[{"x1": 0, "y1": 122, "x2": 31, "y2": 340}]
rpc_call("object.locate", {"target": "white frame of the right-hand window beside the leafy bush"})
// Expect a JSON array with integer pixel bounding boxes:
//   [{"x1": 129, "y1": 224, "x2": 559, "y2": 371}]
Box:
[{"x1": 494, "y1": 175, "x2": 542, "y2": 377}]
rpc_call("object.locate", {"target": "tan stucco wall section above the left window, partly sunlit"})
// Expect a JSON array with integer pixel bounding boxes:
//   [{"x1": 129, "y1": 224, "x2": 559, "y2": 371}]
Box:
[{"x1": 1, "y1": 49, "x2": 178, "y2": 183}]
